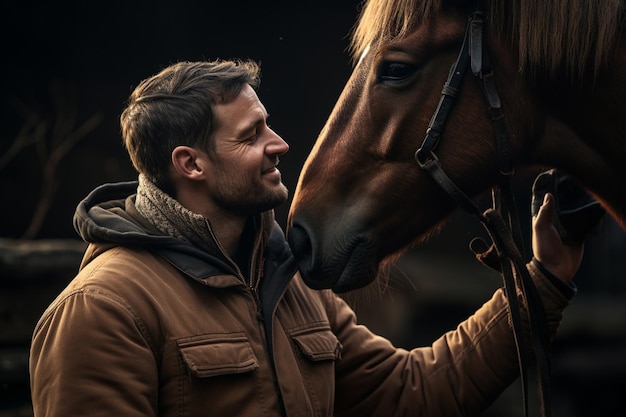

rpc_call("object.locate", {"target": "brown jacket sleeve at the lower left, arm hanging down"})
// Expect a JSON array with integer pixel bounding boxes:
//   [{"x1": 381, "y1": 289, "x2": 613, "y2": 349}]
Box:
[{"x1": 30, "y1": 290, "x2": 158, "y2": 417}]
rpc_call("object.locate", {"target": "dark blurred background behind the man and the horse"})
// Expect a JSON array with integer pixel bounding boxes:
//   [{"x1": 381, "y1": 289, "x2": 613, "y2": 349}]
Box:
[{"x1": 0, "y1": 0, "x2": 626, "y2": 417}]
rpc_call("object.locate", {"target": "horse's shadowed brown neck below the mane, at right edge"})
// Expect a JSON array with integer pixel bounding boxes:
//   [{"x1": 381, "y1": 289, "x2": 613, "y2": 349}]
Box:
[{"x1": 540, "y1": 61, "x2": 626, "y2": 230}]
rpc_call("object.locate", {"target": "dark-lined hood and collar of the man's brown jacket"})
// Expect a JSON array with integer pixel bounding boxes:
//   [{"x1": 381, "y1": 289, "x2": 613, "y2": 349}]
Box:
[{"x1": 74, "y1": 181, "x2": 295, "y2": 290}]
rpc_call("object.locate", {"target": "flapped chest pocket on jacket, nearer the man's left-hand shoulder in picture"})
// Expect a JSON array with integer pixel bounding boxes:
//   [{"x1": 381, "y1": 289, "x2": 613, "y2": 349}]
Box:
[{"x1": 176, "y1": 333, "x2": 259, "y2": 378}]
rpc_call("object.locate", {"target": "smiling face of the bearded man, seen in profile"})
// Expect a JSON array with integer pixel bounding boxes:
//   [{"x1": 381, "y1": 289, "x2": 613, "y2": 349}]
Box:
[{"x1": 207, "y1": 85, "x2": 289, "y2": 216}]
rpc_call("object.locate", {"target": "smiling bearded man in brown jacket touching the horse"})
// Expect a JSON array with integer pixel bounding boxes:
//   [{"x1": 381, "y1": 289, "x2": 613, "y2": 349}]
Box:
[{"x1": 30, "y1": 61, "x2": 582, "y2": 417}]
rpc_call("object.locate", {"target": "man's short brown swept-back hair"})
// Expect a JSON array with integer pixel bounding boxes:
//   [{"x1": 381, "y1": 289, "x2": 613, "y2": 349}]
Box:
[{"x1": 120, "y1": 60, "x2": 261, "y2": 192}]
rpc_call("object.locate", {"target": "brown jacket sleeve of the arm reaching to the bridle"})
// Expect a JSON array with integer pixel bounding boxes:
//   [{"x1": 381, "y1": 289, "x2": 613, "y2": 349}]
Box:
[{"x1": 331, "y1": 263, "x2": 568, "y2": 416}]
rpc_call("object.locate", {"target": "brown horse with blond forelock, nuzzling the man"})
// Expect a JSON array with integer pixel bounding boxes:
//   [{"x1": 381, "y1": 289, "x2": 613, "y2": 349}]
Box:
[{"x1": 287, "y1": 0, "x2": 626, "y2": 293}]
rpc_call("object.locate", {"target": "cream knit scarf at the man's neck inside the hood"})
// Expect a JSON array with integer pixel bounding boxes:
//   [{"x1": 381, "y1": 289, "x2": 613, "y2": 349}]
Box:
[{"x1": 135, "y1": 174, "x2": 223, "y2": 256}]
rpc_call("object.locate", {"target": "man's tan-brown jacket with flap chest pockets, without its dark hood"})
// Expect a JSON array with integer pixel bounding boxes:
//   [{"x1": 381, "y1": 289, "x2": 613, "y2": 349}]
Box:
[{"x1": 31, "y1": 180, "x2": 567, "y2": 417}]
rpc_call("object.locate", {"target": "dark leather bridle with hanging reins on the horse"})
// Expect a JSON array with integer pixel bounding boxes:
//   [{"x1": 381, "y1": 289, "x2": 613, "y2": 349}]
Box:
[{"x1": 415, "y1": 0, "x2": 552, "y2": 417}]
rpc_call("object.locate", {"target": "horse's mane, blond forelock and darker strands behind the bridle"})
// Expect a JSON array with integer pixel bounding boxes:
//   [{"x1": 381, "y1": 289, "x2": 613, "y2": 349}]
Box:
[{"x1": 350, "y1": 0, "x2": 625, "y2": 79}]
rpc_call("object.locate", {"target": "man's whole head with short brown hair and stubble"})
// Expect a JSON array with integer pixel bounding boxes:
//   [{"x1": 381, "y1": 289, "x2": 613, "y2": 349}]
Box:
[{"x1": 121, "y1": 61, "x2": 289, "y2": 218}]
